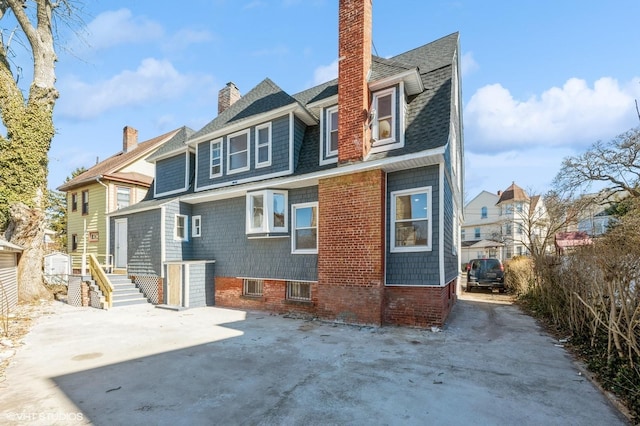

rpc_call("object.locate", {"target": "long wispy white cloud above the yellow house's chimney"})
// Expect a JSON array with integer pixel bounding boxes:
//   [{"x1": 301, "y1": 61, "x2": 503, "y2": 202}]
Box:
[{"x1": 58, "y1": 58, "x2": 198, "y2": 119}]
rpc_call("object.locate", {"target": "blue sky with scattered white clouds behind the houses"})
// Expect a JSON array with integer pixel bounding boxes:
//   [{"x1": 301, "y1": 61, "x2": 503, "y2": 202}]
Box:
[{"x1": 38, "y1": 0, "x2": 640, "y2": 201}]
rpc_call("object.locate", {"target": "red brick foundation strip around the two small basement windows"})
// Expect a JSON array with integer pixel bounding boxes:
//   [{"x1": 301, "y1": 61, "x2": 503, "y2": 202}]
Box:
[{"x1": 215, "y1": 277, "x2": 318, "y2": 315}]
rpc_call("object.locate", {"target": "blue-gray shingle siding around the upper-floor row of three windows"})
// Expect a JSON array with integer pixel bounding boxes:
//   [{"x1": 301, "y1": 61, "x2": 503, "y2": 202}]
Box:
[{"x1": 196, "y1": 115, "x2": 292, "y2": 187}]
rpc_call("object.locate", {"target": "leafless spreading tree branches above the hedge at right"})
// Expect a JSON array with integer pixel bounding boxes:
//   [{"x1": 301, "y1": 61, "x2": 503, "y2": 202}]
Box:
[{"x1": 553, "y1": 128, "x2": 640, "y2": 198}]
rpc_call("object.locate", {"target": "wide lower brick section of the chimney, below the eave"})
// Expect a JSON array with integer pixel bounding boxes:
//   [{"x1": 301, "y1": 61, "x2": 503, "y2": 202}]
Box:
[{"x1": 318, "y1": 170, "x2": 385, "y2": 324}]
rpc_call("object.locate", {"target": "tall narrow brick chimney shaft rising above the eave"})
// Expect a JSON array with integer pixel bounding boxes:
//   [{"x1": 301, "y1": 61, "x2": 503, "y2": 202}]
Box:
[{"x1": 338, "y1": 0, "x2": 372, "y2": 163}]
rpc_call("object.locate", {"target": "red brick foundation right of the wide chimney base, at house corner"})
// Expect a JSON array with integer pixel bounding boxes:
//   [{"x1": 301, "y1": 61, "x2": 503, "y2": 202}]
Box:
[{"x1": 384, "y1": 280, "x2": 456, "y2": 327}]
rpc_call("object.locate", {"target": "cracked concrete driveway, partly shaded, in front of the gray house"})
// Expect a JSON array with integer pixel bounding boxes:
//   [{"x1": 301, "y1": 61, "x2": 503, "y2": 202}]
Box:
[{"x1": 0, "y1": 295, "x2": 626, "y2": 426}]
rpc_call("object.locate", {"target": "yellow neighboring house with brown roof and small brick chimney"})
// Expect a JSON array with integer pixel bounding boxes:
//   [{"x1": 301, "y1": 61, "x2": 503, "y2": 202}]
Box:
[{"x1": 58, "y1": 126, "x2": 180, "y2": 272}]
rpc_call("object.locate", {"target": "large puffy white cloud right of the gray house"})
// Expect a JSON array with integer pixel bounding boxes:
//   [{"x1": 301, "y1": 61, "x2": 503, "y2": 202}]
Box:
[{"x1": 465, "y1": 77, "x2": 640, "y2": 151}]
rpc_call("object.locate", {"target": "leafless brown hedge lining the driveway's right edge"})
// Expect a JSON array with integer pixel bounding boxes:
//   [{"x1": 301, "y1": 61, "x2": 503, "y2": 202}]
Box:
[{"x1": 520, "y1": 206, "x2": 640, "y2": 418}]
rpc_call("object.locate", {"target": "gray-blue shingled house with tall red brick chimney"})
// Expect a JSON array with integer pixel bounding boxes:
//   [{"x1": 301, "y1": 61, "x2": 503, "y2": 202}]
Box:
[{"x1": 110, "y1": 0, "x2": 464, "y2": 326}]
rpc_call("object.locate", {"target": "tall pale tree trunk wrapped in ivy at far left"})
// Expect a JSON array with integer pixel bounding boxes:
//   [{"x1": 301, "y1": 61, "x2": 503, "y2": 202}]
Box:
[{"x1": 0, "y1": 0, "x2": 73, "y2": 301}]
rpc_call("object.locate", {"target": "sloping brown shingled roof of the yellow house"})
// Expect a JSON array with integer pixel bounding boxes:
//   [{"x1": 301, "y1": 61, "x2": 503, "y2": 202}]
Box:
[{"x1": 58, "y1": 129, "x2": 180, "y2": 191}]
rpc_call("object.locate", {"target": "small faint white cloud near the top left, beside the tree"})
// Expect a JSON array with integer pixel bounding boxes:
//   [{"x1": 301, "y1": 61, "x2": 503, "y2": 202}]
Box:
[{"x1": 80, "y1": 9, "x2": 163, "y2": 50}]
